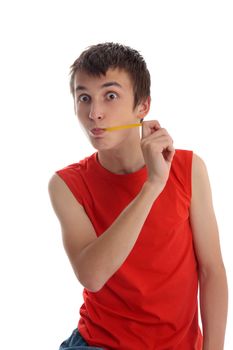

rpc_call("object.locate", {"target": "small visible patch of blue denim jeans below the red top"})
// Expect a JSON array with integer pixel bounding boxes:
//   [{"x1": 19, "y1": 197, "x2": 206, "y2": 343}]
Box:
[{"x1": 59, "y1": 328, "x2": 103, "y2": 350}]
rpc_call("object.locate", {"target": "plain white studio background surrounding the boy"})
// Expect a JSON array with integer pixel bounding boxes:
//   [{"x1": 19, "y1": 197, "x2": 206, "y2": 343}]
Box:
[{"x1": 0, "y1": 0, "x2": 233, "y2": 350}]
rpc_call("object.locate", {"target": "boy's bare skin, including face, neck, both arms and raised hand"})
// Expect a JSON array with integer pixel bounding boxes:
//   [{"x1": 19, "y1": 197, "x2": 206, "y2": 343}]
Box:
[{"x1": 49, "y1": 69, "x2": 227, "y2": 350}]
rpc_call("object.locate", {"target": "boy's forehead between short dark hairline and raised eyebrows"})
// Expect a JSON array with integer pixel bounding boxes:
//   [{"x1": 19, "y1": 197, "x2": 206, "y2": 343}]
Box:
[{"x1": 74, "y1": 68, "x2": 132, "y2": 91}]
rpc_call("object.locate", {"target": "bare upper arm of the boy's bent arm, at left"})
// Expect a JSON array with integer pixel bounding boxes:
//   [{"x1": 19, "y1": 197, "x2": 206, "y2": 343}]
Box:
[{"x1": 48, "y1": 173, "x2": 97, "y2": 277}]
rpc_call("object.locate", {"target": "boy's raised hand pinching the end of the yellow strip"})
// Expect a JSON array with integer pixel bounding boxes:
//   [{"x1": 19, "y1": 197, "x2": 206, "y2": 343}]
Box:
[{"x1": 141, "y1": 120, "x2": 175, "y2": 187}]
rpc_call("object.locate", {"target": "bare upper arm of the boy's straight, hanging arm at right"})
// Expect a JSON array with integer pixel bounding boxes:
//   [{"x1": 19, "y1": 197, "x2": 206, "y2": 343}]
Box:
[{"x1": 190, "y1": 154, "x2": 226, "y2": 272}]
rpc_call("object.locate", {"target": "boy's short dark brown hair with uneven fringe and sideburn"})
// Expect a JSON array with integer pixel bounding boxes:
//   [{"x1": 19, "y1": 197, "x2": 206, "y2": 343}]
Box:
[{"x1": 70, "y1": 42, "x2": 150, "y2": 108}]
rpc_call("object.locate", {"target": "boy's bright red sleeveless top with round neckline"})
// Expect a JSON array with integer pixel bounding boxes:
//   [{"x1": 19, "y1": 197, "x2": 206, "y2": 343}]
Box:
[{"x1": 56, "y1": 150, "x2": 202, "y2": 350}]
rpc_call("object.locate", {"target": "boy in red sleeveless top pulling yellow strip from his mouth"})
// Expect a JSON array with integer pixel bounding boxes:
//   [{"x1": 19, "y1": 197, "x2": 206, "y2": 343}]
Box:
[{"x1": 49, "y1": 43, "x2": 227, "y2": 350}]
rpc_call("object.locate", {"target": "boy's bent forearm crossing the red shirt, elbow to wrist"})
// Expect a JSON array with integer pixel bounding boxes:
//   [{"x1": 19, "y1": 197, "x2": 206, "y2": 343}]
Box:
[{"x1": 77, "y1": 182, "x2": 162, "y2": 292}]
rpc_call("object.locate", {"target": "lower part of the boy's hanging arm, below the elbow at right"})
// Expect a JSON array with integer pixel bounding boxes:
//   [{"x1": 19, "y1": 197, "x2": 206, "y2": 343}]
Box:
[{"x1": 200, "y1": 268, "x2": 228, "y2": 350}]
